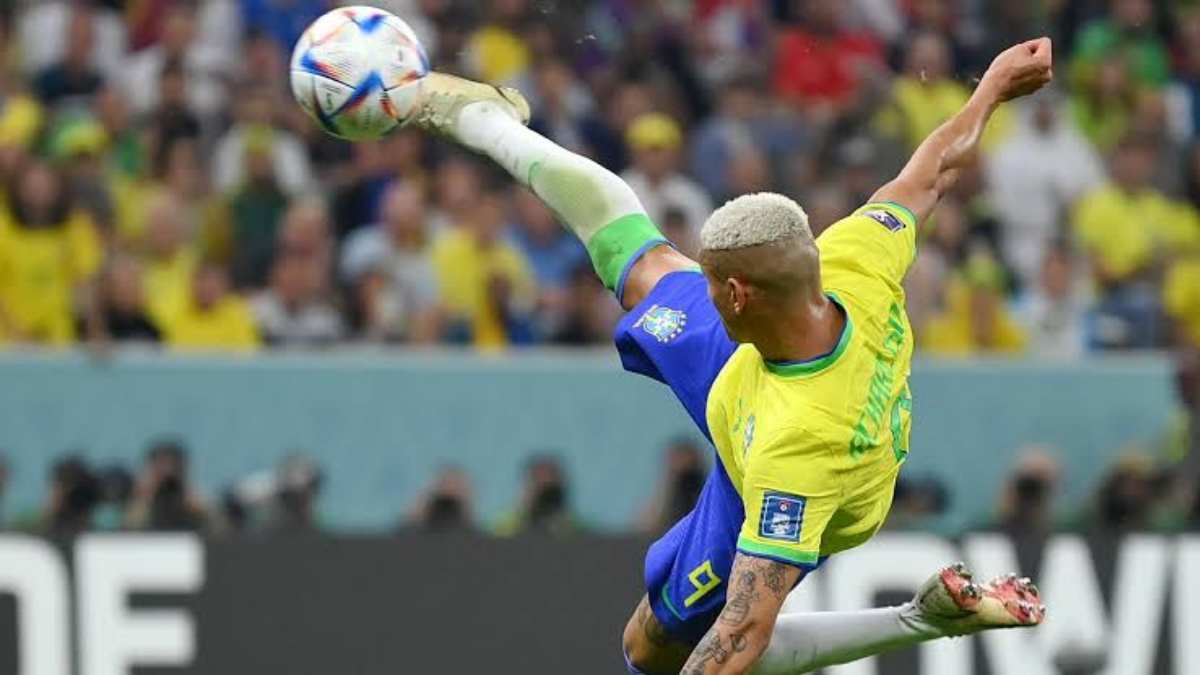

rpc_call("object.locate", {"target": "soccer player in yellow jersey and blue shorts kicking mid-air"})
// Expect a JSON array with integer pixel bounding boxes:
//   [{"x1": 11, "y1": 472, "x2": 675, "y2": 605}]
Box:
[{"x1": 409, "y1": 38, "x2": 1051, "y2": 675}]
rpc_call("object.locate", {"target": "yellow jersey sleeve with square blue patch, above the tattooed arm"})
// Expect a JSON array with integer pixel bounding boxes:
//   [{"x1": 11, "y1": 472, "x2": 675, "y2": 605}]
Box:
[{"x1": 738, "y1": 429, "x2": 840, "y2": 571}]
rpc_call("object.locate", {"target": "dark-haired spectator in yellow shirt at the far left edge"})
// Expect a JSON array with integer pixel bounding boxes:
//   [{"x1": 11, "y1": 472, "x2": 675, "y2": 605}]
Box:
[{"x1": 0, "y1": 161, "x2": 103, "y2": 346}]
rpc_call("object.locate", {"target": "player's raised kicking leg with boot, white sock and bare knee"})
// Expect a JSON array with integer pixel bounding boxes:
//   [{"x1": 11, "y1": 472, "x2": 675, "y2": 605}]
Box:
[{"x1": 412, "y1": 73, "x2": 696, "y2": 309}]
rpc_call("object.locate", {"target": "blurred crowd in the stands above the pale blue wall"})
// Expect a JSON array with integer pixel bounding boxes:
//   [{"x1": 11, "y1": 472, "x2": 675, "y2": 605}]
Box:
[{"x1": 0, "y1": 0, "x2": 1200, "y2": 357}]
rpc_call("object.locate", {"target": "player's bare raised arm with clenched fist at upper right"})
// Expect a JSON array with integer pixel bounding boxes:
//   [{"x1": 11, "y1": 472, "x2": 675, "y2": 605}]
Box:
[{"x1": 871, "y1": 37, "x2": 1054, "y2": 223}]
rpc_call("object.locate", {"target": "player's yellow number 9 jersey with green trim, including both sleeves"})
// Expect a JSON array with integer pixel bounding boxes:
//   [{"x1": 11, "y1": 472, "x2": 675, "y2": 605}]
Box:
[{"x1": 707, "y1": 203, "x2": 917, "y2": 565}]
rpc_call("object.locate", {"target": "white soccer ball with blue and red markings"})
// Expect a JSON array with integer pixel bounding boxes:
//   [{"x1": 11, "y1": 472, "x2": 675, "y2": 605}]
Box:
[{"x1": 292, "y1": 7, "x2": 430, "y2": 141}]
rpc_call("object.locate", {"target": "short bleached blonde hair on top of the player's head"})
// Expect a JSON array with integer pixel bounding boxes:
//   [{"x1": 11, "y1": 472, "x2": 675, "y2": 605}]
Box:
[{"x1": 700, "y1": 192, "x2": 812, "y2": 251}]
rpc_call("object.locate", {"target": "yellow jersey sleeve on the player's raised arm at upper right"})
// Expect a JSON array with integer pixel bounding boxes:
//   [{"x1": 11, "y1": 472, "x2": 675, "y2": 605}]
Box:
[{"x1": 817, "y1": 202, "x2": 917, "y2": 285}]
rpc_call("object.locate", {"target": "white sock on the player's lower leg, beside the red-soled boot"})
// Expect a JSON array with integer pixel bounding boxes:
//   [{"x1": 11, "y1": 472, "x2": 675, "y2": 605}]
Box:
[{"x1": 754, "y1": 603, "x2": 943, "y2": 675}]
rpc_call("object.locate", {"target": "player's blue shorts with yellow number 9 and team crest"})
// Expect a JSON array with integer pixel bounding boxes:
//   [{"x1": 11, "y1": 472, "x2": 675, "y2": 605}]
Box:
[{"x1": 616, "y1": 270, "x2": 820, "y2": 644}]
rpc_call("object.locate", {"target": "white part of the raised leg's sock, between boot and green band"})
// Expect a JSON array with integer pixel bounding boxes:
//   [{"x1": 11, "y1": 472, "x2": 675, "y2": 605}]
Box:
[{"x1": 456, "y1": 101, "x2": 646, "y2": 244}]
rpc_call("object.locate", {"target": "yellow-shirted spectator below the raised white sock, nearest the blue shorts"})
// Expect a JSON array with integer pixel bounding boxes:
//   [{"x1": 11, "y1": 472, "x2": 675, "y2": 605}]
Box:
[{"x1": 431, "y1": 191, "x2": 538, "y2": 350}]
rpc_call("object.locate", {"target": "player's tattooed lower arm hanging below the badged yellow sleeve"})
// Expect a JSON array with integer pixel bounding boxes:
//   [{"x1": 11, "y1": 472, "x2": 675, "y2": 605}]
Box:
[{"x1": 680, "y1": 554, "x2": 802, "y2": 675}]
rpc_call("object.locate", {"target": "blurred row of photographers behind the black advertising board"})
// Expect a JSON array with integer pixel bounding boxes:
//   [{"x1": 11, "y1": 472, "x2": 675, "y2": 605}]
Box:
[{"x1": 0, "y1": 434, "x2": 1200, "y2": 540}]
